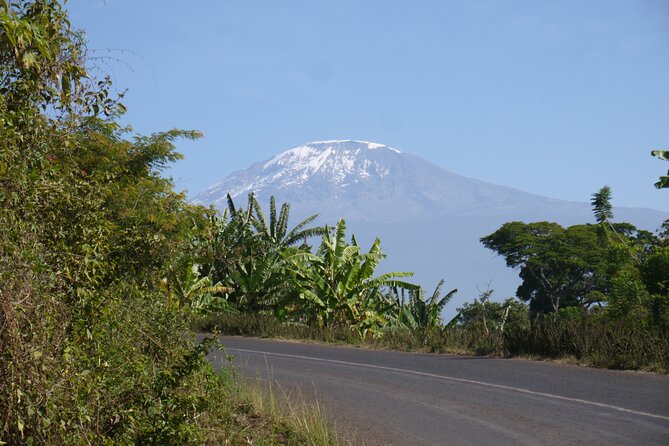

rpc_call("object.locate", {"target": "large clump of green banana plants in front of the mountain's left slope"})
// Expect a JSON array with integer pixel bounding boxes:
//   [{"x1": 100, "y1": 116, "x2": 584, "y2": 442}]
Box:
[{"x1": 199, "y1": 194, "x2": 434, "y2": 336}]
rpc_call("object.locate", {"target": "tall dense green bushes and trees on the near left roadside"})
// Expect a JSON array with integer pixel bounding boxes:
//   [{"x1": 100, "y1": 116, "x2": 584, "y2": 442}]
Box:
[{"x1": 0, "y1": 0, "x2": 340, "y2": 444}]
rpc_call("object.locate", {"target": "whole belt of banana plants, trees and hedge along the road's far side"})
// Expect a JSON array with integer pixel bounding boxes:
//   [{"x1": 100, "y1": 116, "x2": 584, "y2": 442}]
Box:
[{"x1": 196, "y1": 185, "x2": 669, "y2": 373}]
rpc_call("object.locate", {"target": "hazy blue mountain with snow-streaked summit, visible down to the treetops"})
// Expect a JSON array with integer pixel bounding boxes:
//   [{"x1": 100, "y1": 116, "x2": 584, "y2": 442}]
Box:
[{"x1": 194, "y1": 140, "x2": 669, "y2": 313}]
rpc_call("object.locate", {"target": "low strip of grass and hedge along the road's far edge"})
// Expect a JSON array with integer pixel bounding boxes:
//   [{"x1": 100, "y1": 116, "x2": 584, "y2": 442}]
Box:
[{"x1": 197, "y1": 314, "x2": 669, "y2": 373}]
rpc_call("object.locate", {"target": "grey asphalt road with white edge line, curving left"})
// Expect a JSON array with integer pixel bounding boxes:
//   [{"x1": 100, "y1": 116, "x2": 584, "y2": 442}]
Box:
[{"x1": 210, "y1": 337, "x2": 669, "y2": 445}]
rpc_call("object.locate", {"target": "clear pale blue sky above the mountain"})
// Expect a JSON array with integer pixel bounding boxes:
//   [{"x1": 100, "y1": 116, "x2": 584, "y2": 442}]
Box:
[{"x1": 67, "y1": 0, "x2": 669, "y2": 211}]
